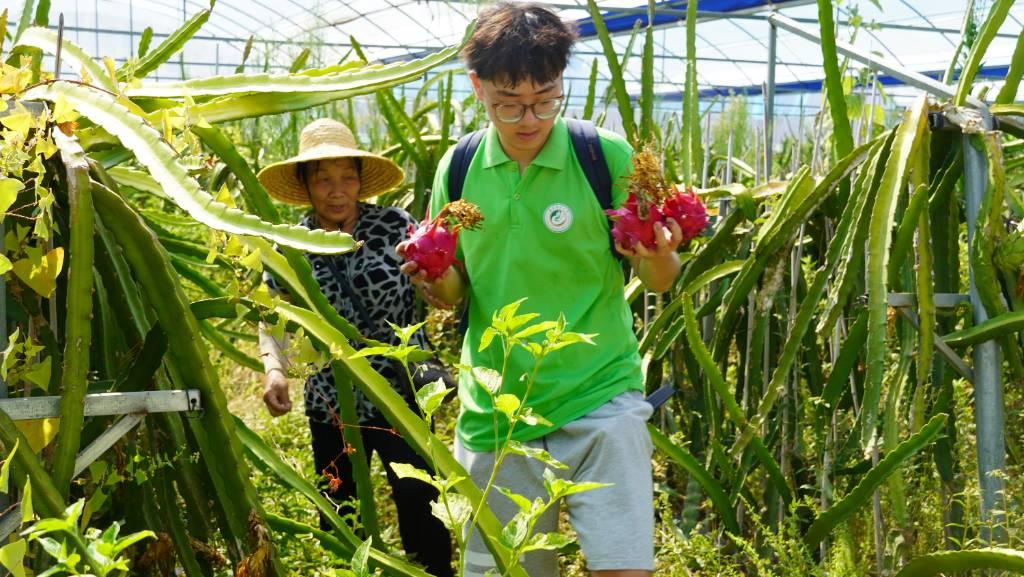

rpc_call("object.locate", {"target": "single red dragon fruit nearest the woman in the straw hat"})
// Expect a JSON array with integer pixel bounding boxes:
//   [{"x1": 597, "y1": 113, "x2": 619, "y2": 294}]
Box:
[{"x1": 406, "y1": 200, "x2": 483, "y2": 281}]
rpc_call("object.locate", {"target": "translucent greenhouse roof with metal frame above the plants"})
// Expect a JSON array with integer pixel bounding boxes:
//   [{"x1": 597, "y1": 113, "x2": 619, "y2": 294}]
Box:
[{"x1": 8, "y1": 0, "x2": 1024, "y2": 117}]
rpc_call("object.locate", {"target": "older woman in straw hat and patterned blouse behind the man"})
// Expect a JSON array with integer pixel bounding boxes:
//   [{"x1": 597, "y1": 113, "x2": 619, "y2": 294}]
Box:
[{"x1": 259, "y1": 119, "x2": 452, "y2": 576}]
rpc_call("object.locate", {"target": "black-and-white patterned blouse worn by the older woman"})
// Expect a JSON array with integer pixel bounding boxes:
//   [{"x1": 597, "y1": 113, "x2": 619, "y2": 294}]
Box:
[{"x1": 263, "y1": 203, "x2": 430, "y2": 422}]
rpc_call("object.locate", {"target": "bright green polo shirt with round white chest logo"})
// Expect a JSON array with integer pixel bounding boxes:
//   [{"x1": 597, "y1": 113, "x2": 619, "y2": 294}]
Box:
[{"x1": 430, "y1": 117, "x2": 643, "y2": 451}]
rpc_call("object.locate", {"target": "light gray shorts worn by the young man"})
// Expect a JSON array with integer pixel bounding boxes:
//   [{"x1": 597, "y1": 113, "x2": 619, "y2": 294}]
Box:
[{"x1": 456, "y1": 390, "x2": 654, "y2": 577}]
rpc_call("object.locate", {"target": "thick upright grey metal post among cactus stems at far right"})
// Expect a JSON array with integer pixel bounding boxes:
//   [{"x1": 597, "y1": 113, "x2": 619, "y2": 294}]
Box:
[{"x1": 964, "y1": 112, "x2": 1007, "y2": 542}]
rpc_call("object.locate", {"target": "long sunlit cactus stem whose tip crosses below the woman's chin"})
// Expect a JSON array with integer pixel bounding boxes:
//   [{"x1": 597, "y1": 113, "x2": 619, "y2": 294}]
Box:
[{"x1": 23, "y1": 81, "x2": 355, "y2": 254}]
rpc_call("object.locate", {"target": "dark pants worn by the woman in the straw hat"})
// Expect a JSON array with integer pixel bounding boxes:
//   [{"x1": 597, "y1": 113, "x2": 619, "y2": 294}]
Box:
[{"x1": 309, "y1": 418, "x2": 454, "y2": 577}]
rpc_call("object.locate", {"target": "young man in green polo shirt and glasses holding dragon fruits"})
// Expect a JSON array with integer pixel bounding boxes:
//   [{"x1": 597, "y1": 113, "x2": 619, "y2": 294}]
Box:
[{"x1": 398, "y1": 3, "x2": 682, "y2": 577}]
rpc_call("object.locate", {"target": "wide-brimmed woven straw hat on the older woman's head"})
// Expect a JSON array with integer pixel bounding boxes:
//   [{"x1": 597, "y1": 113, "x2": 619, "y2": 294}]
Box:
[{"x1": 258, "y1": 118, "x2": 406, "y2": 204}]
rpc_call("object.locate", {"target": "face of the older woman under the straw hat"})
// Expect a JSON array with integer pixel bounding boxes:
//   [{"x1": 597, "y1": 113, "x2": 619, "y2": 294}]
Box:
[{"x1": 305, "y1": 158, "x2": 360, "y2": 230}]
